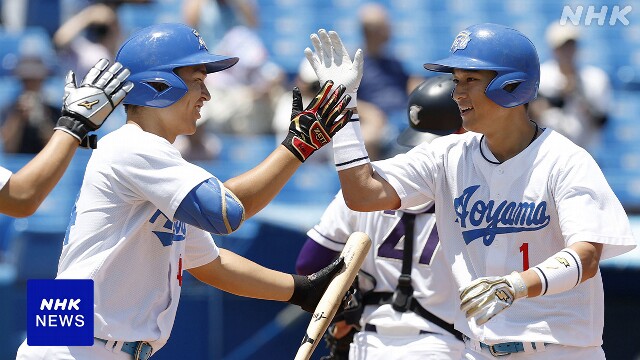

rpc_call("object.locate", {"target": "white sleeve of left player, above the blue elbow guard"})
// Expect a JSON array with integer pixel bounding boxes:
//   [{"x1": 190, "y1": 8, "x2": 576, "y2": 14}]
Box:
[{"x1": 112, "y1": 142, "x2": 214, "y2": 219}]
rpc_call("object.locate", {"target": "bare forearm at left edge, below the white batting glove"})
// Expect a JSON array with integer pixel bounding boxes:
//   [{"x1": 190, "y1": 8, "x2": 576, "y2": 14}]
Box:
[{"x1": 0, "y1": 131, "x2": 79, "y2": 217}]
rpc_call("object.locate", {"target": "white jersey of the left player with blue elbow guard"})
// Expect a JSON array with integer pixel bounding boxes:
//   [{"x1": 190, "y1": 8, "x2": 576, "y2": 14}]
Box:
[{"x1": 16, "y1": 124, "x2": 222, "y2": 359}]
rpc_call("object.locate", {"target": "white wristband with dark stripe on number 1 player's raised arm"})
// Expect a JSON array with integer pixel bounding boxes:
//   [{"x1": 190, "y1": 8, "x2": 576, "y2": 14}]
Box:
[{"x1": 332, "y1": 115, "x2": 370, "y2": 171}]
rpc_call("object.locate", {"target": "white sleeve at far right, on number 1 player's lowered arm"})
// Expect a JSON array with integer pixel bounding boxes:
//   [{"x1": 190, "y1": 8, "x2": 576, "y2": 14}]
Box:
[{"x1": 552, "y1": 151, "x2": 636, "y2": 260}]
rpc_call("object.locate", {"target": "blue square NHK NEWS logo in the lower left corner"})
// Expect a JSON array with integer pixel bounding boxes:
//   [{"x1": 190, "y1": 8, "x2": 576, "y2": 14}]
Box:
[{"x1": 27, "y1": 279, "x2": 93, "y2": 346}]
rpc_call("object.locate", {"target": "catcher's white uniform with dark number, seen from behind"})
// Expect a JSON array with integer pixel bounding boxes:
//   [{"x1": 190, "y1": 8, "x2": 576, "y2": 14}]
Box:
[{"x1": 307, "y1": 192, "x2": 464, "y2": 360}]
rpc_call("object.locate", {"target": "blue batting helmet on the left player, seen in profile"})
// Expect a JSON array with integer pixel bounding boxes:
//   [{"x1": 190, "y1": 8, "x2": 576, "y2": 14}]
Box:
[{"x1": 116, "y1": 24, "x2": 238, "y2": 108}]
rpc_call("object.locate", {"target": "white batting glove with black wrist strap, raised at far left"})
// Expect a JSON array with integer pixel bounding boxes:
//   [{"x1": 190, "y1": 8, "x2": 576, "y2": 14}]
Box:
[{"x1": 55, "y1": 59, "x2": 133, "y2": 149}]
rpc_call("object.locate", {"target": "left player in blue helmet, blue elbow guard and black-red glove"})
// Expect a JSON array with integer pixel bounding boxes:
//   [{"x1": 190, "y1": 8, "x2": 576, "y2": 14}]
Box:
[{"x1": 17, "y1": 24, "x2": 352, "y2": 360}]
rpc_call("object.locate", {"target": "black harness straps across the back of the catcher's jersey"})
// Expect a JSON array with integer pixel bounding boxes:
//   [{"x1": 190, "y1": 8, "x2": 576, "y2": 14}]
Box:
[{"x1": 363, "y1": 207, "x2": 462, "y2": 340}]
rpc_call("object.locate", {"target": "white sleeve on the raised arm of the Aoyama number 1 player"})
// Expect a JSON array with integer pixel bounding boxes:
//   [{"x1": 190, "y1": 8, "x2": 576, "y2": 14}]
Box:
[{"x1": 371, "y1": 144, "x2": 438, "y2": 209}]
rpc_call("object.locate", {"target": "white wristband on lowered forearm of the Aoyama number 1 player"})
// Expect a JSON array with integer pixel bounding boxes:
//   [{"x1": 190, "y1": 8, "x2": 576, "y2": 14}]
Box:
[{"x1": 533, "y1": 248, "x2": 582, "y2": 296}]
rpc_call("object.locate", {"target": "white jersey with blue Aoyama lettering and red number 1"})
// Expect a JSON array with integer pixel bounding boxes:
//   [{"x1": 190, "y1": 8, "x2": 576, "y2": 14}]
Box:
[{"x1": 373, "y1": 129, "x2": 636, "y2": 359}]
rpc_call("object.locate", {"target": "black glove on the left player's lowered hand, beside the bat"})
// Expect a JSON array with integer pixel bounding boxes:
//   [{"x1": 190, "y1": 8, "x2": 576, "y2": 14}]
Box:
[{"x1": 289, "y1": 257, "x2": 344, "y2": 313}]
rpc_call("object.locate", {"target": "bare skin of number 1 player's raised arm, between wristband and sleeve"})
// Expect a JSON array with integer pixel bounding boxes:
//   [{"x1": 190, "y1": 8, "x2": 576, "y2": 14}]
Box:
[{"x1": 338, "y1": 163, "x2": 400, "y2": 211}]
